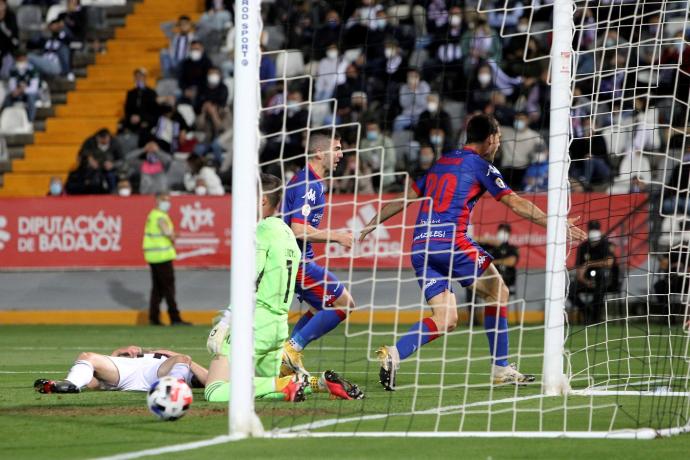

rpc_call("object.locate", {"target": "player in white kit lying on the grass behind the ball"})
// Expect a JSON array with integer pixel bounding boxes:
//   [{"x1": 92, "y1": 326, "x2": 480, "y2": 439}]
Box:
[{"x1": 34, "y1": 345, "x2": 207, "y2": 393}]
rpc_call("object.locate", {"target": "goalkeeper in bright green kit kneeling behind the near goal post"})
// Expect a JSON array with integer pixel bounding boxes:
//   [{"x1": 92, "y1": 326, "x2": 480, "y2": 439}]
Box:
[{"x1": 204, "y1": 174, "x2": 364, "y2": 402}]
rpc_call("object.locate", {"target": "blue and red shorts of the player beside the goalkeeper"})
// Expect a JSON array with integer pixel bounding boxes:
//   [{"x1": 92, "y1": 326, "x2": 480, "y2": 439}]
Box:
[{"x1": 295, "y1": 262, "x2": 345, "y2": 310}]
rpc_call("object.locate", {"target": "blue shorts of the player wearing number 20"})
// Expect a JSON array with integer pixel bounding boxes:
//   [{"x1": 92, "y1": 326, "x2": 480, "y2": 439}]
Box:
[{"x1": 411, "y1": 239, "x2": 493, "y2": 301}]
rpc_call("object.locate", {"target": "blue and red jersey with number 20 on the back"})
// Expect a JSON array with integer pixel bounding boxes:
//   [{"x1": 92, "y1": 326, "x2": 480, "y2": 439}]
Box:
[{"x1": 412, "y1": 148, "x2": 512, "y2": 251}]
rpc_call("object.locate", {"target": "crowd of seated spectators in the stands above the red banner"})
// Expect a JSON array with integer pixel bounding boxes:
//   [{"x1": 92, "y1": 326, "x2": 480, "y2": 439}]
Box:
[{"x1": 0, "y1": 0, "x2": 690, "y2": 200}]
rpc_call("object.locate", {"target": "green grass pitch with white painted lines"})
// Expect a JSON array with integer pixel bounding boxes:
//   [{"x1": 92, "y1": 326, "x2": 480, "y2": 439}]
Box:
[{"x1": 0, "y1": 326, "x2": 690, "y2": 460}]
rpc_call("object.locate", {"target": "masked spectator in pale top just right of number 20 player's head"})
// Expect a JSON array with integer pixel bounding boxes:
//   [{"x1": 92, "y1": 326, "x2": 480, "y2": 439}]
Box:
[{"x1": 501, "y1": 112, "x2": 544, "y2": 190}]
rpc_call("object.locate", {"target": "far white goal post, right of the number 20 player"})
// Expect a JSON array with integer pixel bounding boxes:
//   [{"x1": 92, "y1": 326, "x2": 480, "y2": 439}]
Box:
[{"x1": 542, "y1": 0, "x2": 575, "y2": 396}]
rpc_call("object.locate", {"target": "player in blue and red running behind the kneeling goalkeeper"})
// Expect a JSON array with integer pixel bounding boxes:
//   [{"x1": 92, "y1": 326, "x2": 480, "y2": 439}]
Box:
[{"x1": 281, "y1": 134, "x2": 355, "y2": 375}]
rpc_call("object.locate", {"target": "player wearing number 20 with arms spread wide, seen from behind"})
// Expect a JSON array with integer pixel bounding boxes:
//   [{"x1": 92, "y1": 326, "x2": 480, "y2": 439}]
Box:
[{"x1": 360, "y1": 115, "x2": 587, "y2": 390}]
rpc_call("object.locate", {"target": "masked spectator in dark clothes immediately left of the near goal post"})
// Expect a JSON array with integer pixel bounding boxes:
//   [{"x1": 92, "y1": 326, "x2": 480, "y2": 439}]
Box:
[{"x1": 196, "y1": 67, "x2": 230, "y2": 140}]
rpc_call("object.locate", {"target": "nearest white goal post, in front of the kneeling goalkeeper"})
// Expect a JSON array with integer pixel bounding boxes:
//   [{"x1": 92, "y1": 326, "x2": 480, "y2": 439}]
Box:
[{"x1": 228, "y1": 0, "x2": 263, "y2": 437}]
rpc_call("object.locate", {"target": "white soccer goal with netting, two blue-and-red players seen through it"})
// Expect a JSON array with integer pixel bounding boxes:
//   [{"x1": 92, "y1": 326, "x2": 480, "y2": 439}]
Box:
[{"x1": 231, "y1": 0, "x2": 690, "y2": 438}]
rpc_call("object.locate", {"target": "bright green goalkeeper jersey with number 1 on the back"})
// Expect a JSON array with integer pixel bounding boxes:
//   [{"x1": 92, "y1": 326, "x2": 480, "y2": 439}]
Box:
[{"x1": 256, "y1": 217, "x2": 301, "y2": 315}]
